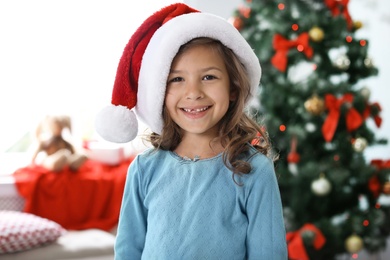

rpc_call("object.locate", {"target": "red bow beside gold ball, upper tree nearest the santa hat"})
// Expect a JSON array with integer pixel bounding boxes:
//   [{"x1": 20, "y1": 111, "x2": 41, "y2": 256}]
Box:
[{"x1": 271, "y1": 32, "x2": 313, "y2": 72}]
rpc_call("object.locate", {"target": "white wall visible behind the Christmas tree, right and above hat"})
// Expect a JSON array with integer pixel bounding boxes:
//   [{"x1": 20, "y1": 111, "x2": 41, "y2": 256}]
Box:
[{"x1": 183, "y1": 0, "x2": 390, "y2": 160}]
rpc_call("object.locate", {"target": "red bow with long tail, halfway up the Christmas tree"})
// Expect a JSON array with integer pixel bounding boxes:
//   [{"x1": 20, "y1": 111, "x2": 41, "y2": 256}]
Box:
[{"x1": 322, "y1": 93, "x2": 363, "y2": 142}]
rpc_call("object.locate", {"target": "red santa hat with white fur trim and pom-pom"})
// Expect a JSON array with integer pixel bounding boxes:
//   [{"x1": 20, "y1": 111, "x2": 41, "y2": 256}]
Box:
[{"x1": 95, "y1": 3, "x2": 261, "y2": 143}]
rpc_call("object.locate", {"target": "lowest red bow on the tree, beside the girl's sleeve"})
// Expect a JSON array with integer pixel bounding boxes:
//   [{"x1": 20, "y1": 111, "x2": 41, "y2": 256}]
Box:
[{"x1": 286, "y1": 224, "x2": 326, "y2": 260}]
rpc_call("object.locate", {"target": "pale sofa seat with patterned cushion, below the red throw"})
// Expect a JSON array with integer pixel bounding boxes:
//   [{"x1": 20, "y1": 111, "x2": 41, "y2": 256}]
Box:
[{"x1": 0, "y1": 197, "x2": 116, "y2": 260}]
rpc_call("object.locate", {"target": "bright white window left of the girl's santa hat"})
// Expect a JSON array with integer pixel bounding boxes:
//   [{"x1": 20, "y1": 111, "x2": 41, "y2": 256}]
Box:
[{"x1": 0, "y1": 0, "x2": 177, "y2": 154}]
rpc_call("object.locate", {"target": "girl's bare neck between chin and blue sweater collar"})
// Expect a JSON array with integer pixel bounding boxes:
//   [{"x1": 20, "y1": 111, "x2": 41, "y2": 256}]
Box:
[{"x1": 174, "y1": 137, "x2": 224, "y2": 159}]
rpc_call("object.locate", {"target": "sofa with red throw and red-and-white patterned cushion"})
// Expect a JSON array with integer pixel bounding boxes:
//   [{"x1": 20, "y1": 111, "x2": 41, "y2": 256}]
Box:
[{"x1": 0, "y1": 155, "x2": 132, "y2": 260}]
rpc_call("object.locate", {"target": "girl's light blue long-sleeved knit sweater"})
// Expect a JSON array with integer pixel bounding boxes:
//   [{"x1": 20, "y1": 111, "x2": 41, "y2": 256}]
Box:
[{"x1": 115, "y1": 148, "x2": 287, "y2": 260}]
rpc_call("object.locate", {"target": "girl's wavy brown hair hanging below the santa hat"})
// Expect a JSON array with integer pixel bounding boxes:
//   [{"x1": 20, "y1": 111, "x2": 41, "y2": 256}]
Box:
[{"x1": 148, "y1": 37, "x2": 276, "y2": 177}]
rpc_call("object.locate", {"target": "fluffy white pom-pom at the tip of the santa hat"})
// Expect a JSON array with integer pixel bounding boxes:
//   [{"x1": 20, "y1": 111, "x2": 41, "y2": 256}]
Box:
[{"x1": 95, "y1": 105, "x2": 138, "y2": 143}]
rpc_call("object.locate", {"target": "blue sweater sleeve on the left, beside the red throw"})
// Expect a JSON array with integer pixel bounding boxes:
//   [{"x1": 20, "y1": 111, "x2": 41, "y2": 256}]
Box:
[{"x1": 114, "y1": 158, "x2": 147, "y2": 260}]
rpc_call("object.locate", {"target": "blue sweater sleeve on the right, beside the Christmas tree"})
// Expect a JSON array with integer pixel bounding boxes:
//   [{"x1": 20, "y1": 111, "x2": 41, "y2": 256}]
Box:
[{"x1": 246, "y1": 157, "x2": 287, "y2": 260}]
